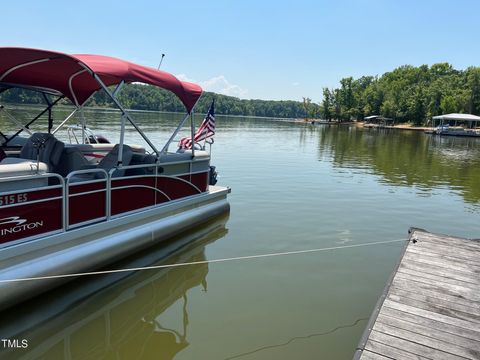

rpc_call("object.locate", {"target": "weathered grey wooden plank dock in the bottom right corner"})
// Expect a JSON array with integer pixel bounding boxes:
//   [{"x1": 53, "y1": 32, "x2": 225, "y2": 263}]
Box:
[{"x1": 354, "y1": 229, "x2": 480, "y2": 360}]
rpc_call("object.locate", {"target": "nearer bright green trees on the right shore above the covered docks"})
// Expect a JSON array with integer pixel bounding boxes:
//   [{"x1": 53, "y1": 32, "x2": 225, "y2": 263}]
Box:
[{"x1": 321, "y1": 63, "x2": 480, "y2": 125}]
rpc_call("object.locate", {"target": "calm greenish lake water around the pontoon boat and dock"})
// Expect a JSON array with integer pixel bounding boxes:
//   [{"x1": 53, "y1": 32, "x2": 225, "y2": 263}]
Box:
[{"x1": 0, "y1": 107, "x2": 480, "y2": 360}]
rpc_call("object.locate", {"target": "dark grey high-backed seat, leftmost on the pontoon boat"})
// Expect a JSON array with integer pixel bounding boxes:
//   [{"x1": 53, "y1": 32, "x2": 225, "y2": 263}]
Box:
[{"x1": 20, "y1": 133, "x2": 65, "y2": 172}]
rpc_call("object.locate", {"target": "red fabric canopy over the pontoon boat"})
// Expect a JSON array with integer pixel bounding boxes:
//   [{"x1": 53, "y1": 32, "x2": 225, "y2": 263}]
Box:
[{"x1": 0, "y1": 47, "x2": 202, "y2": 112}]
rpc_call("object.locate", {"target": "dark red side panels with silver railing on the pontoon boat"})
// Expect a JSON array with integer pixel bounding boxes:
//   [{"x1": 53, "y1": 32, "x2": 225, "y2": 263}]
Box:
[{"x1": 0, "y1": 158, "x2": 209, "y2": 243}]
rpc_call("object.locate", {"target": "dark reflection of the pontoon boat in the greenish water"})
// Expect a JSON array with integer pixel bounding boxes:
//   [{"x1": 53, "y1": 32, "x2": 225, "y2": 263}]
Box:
[{"x1": 0, "y1": 215, "x2": 228, "y2": 359}]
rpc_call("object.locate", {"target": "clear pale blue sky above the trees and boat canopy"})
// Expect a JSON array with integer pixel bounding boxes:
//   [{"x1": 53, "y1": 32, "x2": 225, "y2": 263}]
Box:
[{"x1": 0, "y1": 0, "x2": 480, "y2": 102}]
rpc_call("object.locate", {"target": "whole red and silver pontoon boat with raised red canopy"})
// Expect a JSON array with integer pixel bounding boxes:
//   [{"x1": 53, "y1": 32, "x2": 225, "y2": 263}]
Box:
[{"x1": 0, "y1": 48, "x2": 230, "y2": 309}]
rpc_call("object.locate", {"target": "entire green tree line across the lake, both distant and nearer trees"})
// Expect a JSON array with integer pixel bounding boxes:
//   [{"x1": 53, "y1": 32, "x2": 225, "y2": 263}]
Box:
[{"x1": 0, "y1": 63, "x2": 480, "y2": 125}]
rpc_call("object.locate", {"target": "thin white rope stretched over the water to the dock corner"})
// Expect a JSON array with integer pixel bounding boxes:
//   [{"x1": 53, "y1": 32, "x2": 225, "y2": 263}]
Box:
[{"x1": 0, "y1": 239, "x2": 408, "y2": 284}]
